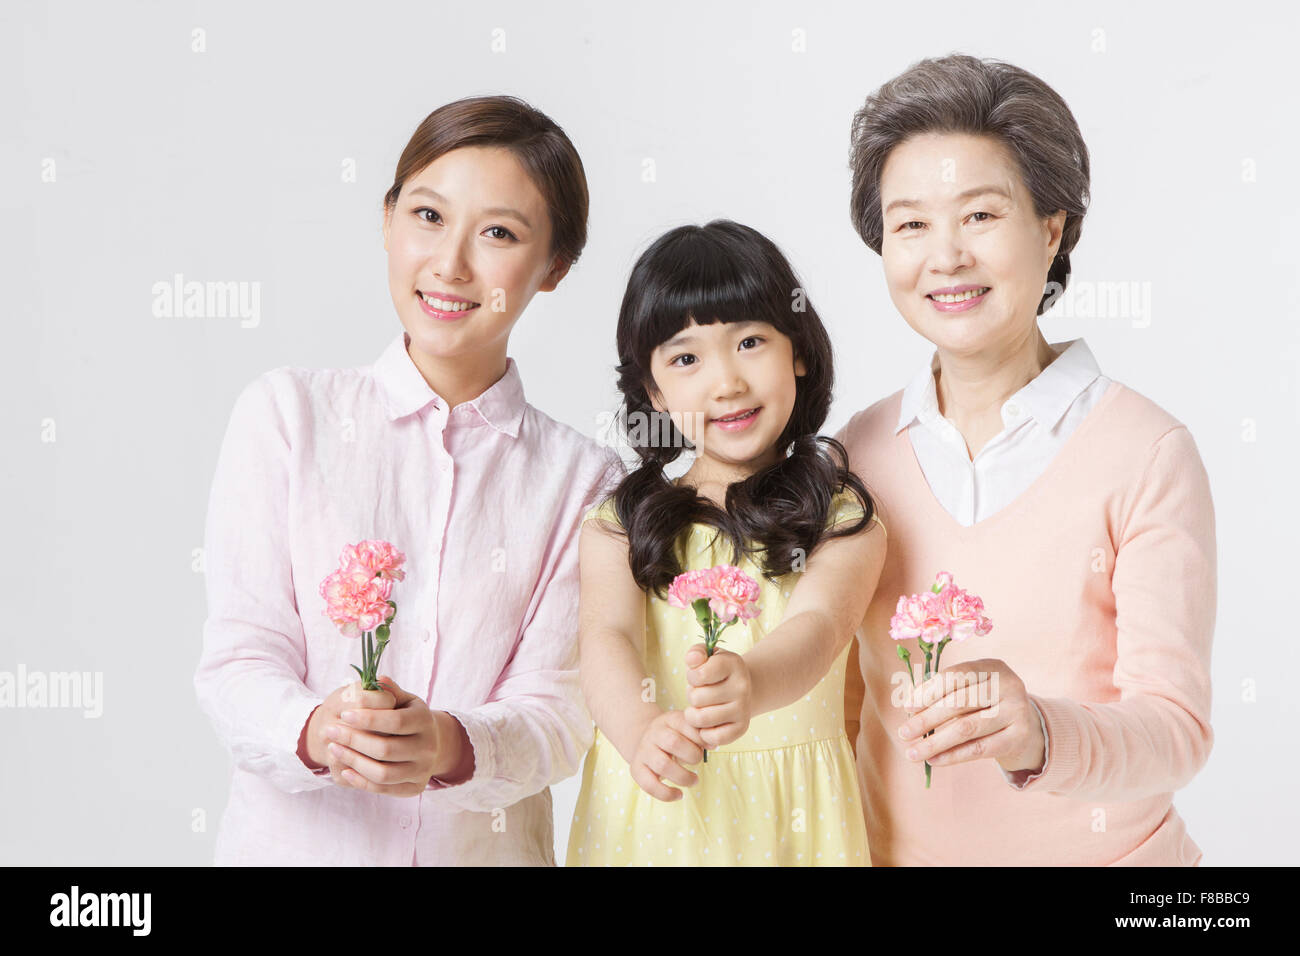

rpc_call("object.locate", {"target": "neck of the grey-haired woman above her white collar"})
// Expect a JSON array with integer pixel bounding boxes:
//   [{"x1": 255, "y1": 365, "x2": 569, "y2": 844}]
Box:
[{"x1": 935, "y1": 323, "x2": 1057, "y2": 421}]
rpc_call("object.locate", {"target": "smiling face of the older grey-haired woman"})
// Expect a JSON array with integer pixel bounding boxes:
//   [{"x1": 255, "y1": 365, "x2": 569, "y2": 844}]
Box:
[{"x1": 880, "y1": 133, "x2": 1065, "y2": 355}]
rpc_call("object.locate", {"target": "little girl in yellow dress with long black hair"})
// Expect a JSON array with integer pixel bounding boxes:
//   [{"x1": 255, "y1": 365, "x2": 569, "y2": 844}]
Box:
[{"x1": 567, "y1": 220, "x2": 885, "y2": 866}]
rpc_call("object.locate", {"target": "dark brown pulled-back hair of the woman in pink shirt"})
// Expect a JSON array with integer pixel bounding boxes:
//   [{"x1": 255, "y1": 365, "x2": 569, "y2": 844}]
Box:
[{"x1": 384, "y1": 96, "x2": 589, "y2": 265}]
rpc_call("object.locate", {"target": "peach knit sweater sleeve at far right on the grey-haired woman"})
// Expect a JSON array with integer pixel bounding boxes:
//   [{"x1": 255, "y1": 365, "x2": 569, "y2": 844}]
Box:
[{"x1": 1023, "y1": 425, "x2": 1217, "y2": 800}]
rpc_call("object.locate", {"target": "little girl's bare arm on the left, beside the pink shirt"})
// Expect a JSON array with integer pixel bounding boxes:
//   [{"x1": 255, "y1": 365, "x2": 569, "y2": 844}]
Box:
[{"x1": 579, "y1": 516, "x2": 663, "y2": 763}]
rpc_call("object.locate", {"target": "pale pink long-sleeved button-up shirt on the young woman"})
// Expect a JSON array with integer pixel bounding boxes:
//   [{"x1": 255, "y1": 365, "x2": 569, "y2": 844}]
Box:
[{"x1": 194, "y1": 332, "x2": 624, "y2": 865}]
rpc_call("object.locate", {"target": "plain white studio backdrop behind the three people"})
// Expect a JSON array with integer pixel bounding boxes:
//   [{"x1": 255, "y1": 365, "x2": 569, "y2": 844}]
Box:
[{"x1": 0, "y1": 1, "x2": 1300, "y2": 865}]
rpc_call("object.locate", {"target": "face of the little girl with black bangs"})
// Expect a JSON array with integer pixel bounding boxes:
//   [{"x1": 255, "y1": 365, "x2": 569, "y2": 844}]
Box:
[{"x1": 650, "y1": 320, "x2": 806, "y2": 481}]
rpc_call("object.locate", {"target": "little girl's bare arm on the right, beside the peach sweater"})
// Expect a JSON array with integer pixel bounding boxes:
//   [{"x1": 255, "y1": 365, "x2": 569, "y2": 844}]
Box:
[{"x1": 745, "y1": 522, "x2": 885, "y2": 715}]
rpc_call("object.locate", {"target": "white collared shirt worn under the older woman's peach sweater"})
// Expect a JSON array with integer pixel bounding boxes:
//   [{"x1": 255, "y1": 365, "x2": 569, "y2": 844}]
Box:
[{"x1": 894, "y1": 338, "x2": 1110, "y2": 788}]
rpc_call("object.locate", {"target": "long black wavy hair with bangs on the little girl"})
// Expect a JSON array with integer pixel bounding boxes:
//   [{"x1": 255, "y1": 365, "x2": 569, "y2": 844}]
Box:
[{"x1": 614, "y1": 219, "x2": 875, "y2": 597}]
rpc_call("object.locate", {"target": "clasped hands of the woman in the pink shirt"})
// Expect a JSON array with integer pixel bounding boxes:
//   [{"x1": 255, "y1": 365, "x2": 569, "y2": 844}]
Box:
[{"x1": 322, "y1": 676, "x2": 473, "y2": 797}]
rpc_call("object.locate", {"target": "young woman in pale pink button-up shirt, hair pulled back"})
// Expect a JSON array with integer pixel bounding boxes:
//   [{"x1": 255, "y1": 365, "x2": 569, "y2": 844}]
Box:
[{"x1": 195, "y1": 96, "x2": 623, "y2": 866}]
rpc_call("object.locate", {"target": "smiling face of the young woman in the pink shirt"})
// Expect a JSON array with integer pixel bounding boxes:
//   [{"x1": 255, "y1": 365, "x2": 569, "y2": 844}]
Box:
[{"x1": 384, "y1": 146, "x2": 568, "y2": 362}]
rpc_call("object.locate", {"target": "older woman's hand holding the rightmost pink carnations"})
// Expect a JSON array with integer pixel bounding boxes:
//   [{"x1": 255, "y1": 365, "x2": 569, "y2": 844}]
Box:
[{"x1": 898, "y1": 658, "x2": 1045, "y2": 773}]
